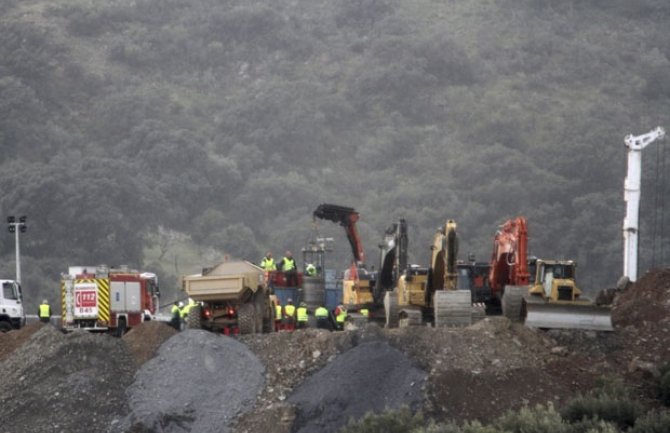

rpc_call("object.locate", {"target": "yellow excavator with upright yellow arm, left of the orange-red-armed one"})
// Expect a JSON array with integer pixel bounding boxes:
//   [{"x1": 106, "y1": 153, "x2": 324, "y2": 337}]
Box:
[{"x1": 384, "y1": 220, "x2": 472, "y2": 327}]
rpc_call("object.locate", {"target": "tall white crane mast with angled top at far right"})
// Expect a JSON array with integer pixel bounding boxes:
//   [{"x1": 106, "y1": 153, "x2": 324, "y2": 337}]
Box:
[{"x1": 623, "y1": 126, "x2": 665, "y2": 282}]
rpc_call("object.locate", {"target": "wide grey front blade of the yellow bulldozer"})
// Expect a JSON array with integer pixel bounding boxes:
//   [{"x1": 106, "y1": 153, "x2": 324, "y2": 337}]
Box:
[{"x1": 524, "y1": 302, "x2": 614, "y2": 331}]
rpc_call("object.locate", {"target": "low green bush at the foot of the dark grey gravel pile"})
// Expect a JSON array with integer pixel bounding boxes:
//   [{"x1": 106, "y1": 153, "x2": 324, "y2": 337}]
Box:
[{"x1": 339, "y1": 406, "x2": 424, "y2": 433}]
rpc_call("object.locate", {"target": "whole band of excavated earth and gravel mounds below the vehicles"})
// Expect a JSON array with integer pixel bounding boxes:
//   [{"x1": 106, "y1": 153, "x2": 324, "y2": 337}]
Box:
[{"x1": 0, "y1": 269, "x2": 670, "y2": 433}]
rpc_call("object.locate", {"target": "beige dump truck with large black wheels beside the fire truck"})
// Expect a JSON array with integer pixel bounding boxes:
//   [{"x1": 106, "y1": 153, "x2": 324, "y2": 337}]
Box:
[{"x1": 182, "y1": 260, "x2": 277, "y2": 335}]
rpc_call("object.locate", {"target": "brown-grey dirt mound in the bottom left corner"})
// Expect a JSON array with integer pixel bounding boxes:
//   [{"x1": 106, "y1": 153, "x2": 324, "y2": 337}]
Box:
[{"x1": 0, "y1": 326, "x2": 135, "y2": 433}]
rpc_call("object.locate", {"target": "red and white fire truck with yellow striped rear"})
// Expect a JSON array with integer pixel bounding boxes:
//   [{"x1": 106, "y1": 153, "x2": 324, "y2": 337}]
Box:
[{"x1": 61, "y1": 265, "x2": 160, "y2": 336}]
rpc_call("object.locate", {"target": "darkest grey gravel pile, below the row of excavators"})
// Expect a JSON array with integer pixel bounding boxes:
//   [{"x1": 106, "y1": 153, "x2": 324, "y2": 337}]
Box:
[{"x1": 288, "y1": 340, "x2": 427, "y2": 433}]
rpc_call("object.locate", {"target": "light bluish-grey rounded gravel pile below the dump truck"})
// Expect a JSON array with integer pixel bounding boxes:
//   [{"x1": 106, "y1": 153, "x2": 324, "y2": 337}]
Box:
[{"x1": 112, "y1": 330, "x2": 265, "y2": 433}]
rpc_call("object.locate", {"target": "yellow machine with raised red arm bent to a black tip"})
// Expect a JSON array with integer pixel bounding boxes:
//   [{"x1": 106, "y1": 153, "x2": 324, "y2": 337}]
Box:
[{"x1": 313, "y1": 204, "x2": 379, "y2": 312}]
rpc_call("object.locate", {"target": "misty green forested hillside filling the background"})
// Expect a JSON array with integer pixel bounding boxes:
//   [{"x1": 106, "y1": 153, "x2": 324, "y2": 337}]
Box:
[{"x1": 0, "y1": 0, "x2": 670, "y2": 305}]
